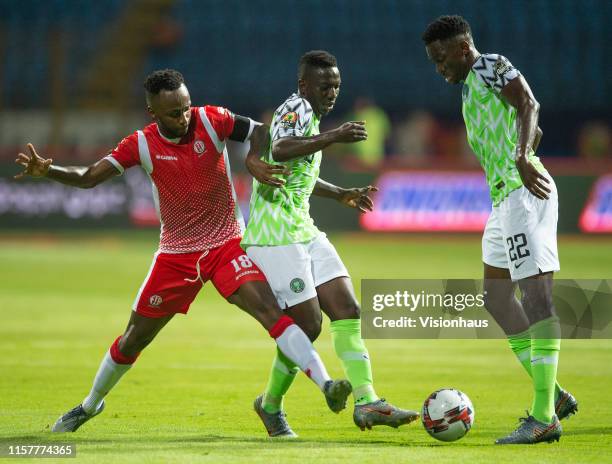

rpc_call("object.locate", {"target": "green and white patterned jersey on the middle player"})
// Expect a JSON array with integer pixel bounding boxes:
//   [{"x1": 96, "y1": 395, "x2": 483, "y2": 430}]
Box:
[{"x1": 242, "y1": 93, "x2": 322, "y2": 247}]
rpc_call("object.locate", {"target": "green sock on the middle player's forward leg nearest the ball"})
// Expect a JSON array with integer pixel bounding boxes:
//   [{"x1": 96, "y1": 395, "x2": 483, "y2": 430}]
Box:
[{"x1": 330, "y1": 319, "x2": 378, "y2": 405}]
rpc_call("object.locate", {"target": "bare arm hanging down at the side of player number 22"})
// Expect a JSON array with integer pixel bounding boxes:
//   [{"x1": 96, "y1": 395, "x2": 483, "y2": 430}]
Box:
[{"x1": 501, "y1": 76, "x2": 550, "y2": 200}]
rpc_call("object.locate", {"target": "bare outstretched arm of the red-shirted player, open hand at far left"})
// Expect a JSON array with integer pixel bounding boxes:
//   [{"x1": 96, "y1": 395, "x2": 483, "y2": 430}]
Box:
[{"x1": 15, "y1": 143, "x2": 119, "y2": 188}]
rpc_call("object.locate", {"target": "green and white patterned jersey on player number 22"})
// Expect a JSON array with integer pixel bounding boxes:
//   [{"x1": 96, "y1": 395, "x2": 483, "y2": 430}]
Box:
[{"x1": 462, "y1": 54, "x2": 545, "y2": 206}]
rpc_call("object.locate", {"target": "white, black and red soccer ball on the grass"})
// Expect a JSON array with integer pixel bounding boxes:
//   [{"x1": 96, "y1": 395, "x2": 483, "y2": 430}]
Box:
[{"x1": 421, "y1": 388, "x2": 474, "y2": 441}]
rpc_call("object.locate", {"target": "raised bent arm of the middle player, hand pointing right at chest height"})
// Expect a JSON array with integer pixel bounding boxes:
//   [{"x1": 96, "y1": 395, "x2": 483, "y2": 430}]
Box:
[{"x1": 272, "y1": 121, "x2": 368, "y2": 161}]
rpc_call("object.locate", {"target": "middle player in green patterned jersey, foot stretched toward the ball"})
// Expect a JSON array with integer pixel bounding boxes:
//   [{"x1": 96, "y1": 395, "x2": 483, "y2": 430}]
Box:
[{"x1": 242, "y1": 50, "x2": 419, "y2": 437}]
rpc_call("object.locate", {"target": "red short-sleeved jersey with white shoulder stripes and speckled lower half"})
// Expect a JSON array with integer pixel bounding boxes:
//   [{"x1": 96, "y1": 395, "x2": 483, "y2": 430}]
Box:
[{"x1": 106, "y1": 106, "x2": 244, "y2": 253}]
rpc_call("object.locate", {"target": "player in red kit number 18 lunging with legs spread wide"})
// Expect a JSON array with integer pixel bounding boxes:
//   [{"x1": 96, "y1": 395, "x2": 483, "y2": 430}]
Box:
[{"x1": 15, "y1": 69, "x2": 351, "y2": 432}]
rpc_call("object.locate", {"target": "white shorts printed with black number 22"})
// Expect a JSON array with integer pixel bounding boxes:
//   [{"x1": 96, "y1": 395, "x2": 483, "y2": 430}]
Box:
[{"x1": 482, "y1": 174, "x2": 559, "y2": 281}]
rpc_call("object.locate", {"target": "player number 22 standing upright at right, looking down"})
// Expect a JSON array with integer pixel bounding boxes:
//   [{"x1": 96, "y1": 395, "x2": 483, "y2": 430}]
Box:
[{"x1": 423, "y1": 16, "x2": 578, "y2": 444}]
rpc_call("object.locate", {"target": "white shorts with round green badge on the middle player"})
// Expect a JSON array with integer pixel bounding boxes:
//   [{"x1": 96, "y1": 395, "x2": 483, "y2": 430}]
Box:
[{"x1": 246, "y1": 234, "x2": 348, "y2": 309}]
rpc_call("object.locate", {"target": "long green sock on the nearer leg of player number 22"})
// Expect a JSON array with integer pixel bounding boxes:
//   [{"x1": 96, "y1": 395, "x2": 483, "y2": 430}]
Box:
[{"x1": 529, "y1": 317, "x2": 561, "y2": 424}]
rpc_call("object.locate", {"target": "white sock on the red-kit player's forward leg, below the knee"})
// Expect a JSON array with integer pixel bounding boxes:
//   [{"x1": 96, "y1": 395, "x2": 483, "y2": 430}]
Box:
[{"x1": 275, "y1": 324, "x2": 331, "y2": 390}]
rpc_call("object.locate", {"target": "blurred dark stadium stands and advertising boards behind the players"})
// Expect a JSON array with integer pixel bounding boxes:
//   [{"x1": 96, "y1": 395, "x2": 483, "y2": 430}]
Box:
[{"x1": 0, "y1": 0, "x2": 612, "y2": 233}]
